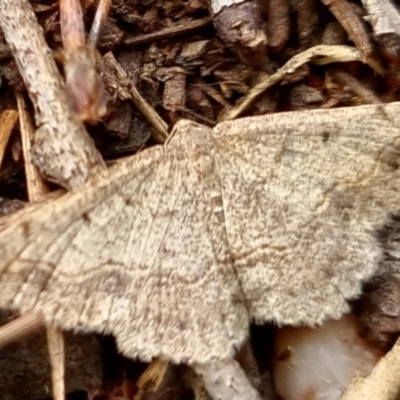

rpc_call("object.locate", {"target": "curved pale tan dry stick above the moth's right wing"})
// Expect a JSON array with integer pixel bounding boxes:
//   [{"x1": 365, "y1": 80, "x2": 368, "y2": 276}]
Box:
[{"x1": 221, "y1": 45, "x2": 370, "y2": 120}]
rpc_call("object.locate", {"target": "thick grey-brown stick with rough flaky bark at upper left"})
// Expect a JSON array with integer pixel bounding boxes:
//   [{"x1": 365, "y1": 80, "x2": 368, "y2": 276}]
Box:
[{"x1": 0, "y1": 0, "x2": 104, "y2": 189}]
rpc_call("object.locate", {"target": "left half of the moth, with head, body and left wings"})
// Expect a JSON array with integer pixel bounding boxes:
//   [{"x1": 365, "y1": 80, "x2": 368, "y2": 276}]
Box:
[{"x1": 0, "y1": 122, "x2": 248, "y2": 363}]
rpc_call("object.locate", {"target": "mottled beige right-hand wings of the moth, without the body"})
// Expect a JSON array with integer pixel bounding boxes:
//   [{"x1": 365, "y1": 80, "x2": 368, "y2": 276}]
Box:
[{"x1": 213, "y1": 103, "x2": 400, "y2": 324}]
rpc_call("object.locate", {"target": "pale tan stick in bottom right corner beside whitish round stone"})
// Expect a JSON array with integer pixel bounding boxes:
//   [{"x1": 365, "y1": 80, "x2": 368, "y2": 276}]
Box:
[{"x1": 341, "y1": 339, "x2": 400, "y2": 400}]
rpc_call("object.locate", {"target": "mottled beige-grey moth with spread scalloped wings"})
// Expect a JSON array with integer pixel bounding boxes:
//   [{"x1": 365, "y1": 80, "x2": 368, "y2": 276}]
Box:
[{"x1": 0, "y1": 103, "x2": 400, "y2": 364}]
